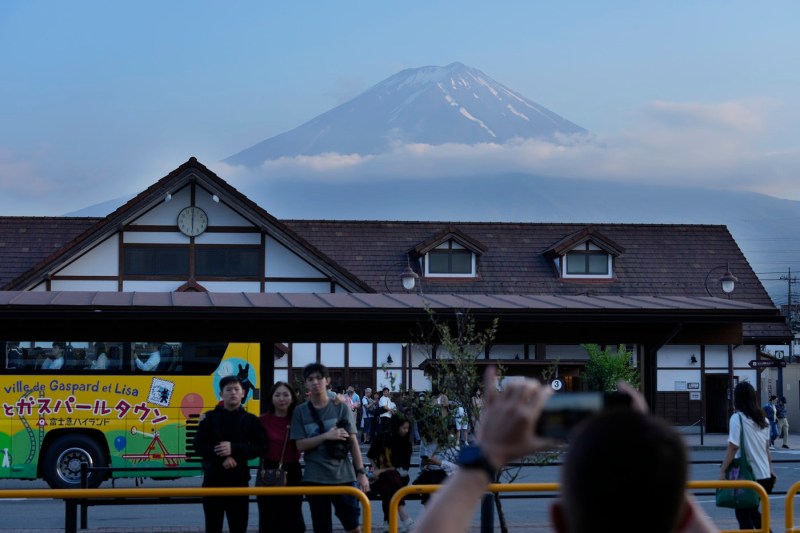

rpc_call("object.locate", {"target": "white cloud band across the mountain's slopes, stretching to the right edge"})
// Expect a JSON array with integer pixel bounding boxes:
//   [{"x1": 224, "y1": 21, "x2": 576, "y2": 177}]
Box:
[{"x1": 221, "y1": 95, "x2": 800, "y2": 198}]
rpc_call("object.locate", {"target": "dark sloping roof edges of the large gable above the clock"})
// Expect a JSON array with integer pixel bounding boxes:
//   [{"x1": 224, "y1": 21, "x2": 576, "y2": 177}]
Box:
[{"x1": 0, "y1": 157, "x2": 371, "y2": 291}]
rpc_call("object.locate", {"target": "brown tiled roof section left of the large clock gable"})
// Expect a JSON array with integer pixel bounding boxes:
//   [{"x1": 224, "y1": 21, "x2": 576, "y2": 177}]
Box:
[{"x1": 0, "y1": 217, "x2": 102, "y2": 287}]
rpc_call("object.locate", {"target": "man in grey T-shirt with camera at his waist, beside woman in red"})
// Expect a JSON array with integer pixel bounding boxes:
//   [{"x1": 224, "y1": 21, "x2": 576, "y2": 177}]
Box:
[{"x1": 290, "y1": 363, "x2": 369, "y2": 533}]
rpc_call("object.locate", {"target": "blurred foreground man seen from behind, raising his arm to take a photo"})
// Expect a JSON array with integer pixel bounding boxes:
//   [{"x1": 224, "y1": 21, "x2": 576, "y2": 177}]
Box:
[{"x1": 414, "y1": 367, "x2": 718, "y2": 533}]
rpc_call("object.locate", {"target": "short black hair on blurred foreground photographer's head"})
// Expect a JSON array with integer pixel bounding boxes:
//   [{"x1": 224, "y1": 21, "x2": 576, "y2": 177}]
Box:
[{"x1": 561, "y1": 409, "x2": 688, "y2": 533}]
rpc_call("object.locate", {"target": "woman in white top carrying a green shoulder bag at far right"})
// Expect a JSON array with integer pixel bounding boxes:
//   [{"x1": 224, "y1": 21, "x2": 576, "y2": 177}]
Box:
[{"x1": 720, "y1": 381, "x2": 775, "y2": 529}]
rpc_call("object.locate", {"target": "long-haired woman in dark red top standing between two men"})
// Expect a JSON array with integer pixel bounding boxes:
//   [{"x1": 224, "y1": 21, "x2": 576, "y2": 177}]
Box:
[{"x1": 256, "y1": 381, "x2": 306, "y2": 533}]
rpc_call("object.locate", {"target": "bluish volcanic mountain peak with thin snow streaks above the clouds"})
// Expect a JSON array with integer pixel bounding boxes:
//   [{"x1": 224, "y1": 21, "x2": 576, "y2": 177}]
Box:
[{"x1": 226, "y1": 63, "x2": 586, "y2": 166}]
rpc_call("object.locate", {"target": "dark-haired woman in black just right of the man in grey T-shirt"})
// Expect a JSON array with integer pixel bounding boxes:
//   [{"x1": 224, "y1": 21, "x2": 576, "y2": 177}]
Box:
[{"x1": 367, "y1": 416, "x2": 414, "y2": 533}]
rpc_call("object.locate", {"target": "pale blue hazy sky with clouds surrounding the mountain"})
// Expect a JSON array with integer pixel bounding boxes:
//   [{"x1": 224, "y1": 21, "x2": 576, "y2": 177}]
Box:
[{"x1": 0, "y1": 0, "x2": 800, "y2": 215}]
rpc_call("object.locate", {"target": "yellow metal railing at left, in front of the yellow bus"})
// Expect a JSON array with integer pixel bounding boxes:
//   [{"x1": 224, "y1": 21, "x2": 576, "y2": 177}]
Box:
[{"x1": 0, "y1": 485, "x2": 372, "y2": 533}]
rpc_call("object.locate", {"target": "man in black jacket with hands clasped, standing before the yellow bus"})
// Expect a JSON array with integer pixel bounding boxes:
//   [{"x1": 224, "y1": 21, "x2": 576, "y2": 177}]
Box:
[{"x1": 194, "y1": 376, "x2": 265, "y2": 533}]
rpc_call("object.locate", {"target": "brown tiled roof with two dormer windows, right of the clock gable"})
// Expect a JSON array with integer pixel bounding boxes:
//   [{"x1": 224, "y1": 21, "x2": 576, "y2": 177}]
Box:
[{"x1": 283, "y1": 220, "x2": 773, "y2": 306}]
